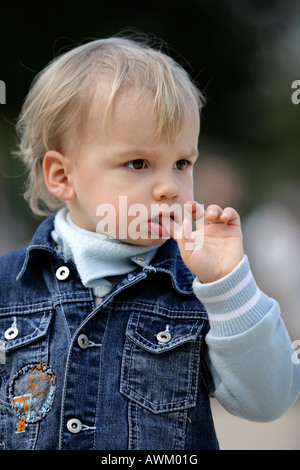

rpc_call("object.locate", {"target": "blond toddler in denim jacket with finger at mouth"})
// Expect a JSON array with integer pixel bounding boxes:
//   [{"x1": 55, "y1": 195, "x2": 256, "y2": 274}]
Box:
[{"x1": 0, "y1": 38, "x2": 300, "y2": 450}]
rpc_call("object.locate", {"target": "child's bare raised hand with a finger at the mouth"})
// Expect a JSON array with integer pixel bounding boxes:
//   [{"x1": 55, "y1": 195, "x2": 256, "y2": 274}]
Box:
[{"x1": 166, "y1": 201, "x2": 244, "y2": 283}]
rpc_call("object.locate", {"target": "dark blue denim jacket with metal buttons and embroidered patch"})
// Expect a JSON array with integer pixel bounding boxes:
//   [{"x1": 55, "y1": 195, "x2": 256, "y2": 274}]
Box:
[{"x1": 0, "y1": 215, "x2": 218, "y2": 450}]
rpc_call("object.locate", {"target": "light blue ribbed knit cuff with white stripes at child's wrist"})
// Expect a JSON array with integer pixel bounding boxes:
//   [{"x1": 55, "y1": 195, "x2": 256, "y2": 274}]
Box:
[{"x1": 193, "y1": 255, "x2": 273, "y2": 337}]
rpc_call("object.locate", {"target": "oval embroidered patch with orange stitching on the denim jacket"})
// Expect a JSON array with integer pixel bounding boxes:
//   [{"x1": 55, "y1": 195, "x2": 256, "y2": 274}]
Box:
[{"x1": 10, "y1": 362, "x2": 57, "y2": 432}]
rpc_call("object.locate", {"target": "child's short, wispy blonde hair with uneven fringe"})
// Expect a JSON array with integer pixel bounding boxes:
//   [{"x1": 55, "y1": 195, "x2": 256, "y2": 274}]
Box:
[{"x1": 17, "y1": 37, "x2": 204, "y2": 215}]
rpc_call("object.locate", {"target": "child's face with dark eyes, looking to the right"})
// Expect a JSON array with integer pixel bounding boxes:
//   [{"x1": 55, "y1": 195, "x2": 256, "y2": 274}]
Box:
[{"x1": 64, "y1": 92, "x2": 199, "y2": 245}]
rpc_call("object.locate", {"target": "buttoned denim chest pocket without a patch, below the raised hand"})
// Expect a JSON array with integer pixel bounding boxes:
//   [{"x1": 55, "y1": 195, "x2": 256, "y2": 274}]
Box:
[{"x1": 120, "y1": 312, "x2": 207, "y2": 413}]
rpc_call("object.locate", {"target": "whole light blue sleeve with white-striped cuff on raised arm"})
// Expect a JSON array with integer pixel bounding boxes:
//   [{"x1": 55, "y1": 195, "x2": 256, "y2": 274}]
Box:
[{"x1": 193, "y1": 255, "x2": 300, "y2": 422}]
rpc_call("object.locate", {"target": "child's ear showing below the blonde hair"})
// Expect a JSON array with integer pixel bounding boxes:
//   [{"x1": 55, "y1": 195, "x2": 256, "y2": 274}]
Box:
[{"x1": 43, "y1": 150, "x2": 76, "y2": 201}]
